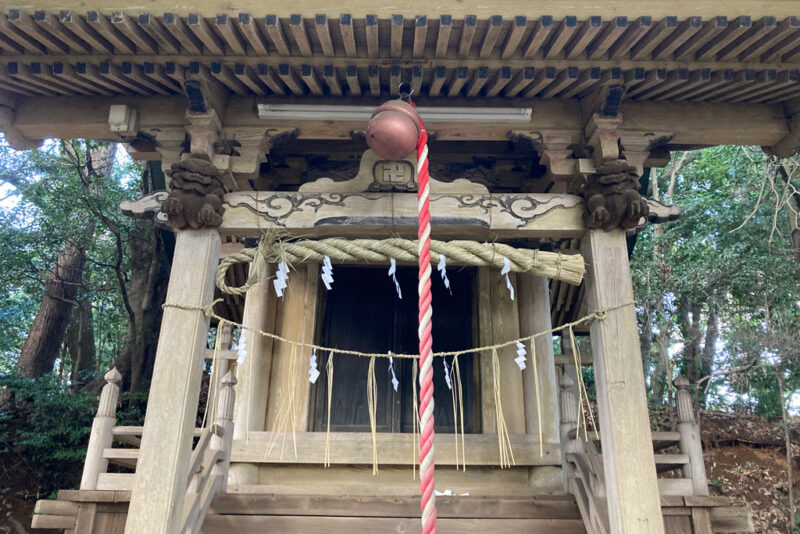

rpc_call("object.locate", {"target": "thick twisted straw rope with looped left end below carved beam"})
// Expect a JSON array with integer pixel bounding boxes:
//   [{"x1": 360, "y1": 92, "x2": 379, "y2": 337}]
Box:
[{"x1": 217, "y1": 236, "x2": 586, "y2": 295}]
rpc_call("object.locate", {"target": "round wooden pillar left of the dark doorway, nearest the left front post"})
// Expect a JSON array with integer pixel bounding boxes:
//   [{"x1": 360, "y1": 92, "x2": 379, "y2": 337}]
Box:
[{"x1": 228, "y1": 264, "x2": 276, "y2": 485}]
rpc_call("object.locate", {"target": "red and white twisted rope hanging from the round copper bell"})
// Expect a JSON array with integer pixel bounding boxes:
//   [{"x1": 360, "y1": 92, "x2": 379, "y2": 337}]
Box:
[{"x1": 411, "y1": 103, "x2": 436, "y2": 534}]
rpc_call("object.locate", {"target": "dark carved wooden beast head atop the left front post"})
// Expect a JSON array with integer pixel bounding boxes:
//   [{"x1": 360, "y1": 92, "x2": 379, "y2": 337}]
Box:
[{"x1": 161, "y1": 158, "x2": 225, "y2": 230}]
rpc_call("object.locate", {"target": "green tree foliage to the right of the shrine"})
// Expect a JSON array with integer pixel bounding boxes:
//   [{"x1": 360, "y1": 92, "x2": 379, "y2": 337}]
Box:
[{"x1": 632, "y1": 147, "x2": 800, "y2": 416}]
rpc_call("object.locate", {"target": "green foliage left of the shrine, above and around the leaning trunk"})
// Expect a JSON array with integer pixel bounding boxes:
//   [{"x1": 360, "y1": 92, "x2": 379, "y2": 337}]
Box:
[{"x1": 0, "y1": 137, "x2": 141, "y2": 373}]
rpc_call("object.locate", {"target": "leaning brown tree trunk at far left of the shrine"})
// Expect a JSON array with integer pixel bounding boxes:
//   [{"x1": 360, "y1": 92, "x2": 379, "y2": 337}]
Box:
[{"x1": 14, "y1": 245, "x2": 86, "y2": 378}]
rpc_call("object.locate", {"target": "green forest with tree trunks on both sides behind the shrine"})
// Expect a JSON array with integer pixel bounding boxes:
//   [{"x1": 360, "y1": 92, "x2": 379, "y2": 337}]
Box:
[{"x1": 0, "y1": 138, "x2": 800, "y2": 532}]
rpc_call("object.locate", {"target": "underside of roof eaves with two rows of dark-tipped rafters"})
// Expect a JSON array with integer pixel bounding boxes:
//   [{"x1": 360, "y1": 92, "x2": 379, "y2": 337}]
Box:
[{"x1": 0, "y1": 11, "x2": 800, "y2": 103}]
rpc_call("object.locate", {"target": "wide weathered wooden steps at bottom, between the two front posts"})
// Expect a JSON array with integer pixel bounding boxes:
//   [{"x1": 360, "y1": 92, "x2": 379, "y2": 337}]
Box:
[{"x1": 201, "y1": 493, "x2": 586, "y2": 534}]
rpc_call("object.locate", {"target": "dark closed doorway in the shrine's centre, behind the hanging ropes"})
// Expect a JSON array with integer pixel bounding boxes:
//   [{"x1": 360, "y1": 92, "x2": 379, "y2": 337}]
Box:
[{"x1": 310, "y1": 266, "x2": 479, "y2": 433}]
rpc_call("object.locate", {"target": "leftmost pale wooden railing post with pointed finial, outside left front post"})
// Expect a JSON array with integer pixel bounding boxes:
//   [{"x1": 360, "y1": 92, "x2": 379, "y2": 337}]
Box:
[{"x1": 81, "y1": 367, "x2": 122, "y2": 490}]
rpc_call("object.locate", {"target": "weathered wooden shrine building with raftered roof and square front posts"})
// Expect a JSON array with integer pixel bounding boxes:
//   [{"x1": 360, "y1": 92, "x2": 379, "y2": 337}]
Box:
[{"x1": 0, "y1": 0, "x2": 800, "y2": 534}]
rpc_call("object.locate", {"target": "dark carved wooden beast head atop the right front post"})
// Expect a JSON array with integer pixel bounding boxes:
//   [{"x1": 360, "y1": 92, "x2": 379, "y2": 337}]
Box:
[{"x1": 583, "y1": 159, "x2": 650, "y2": 230}]
